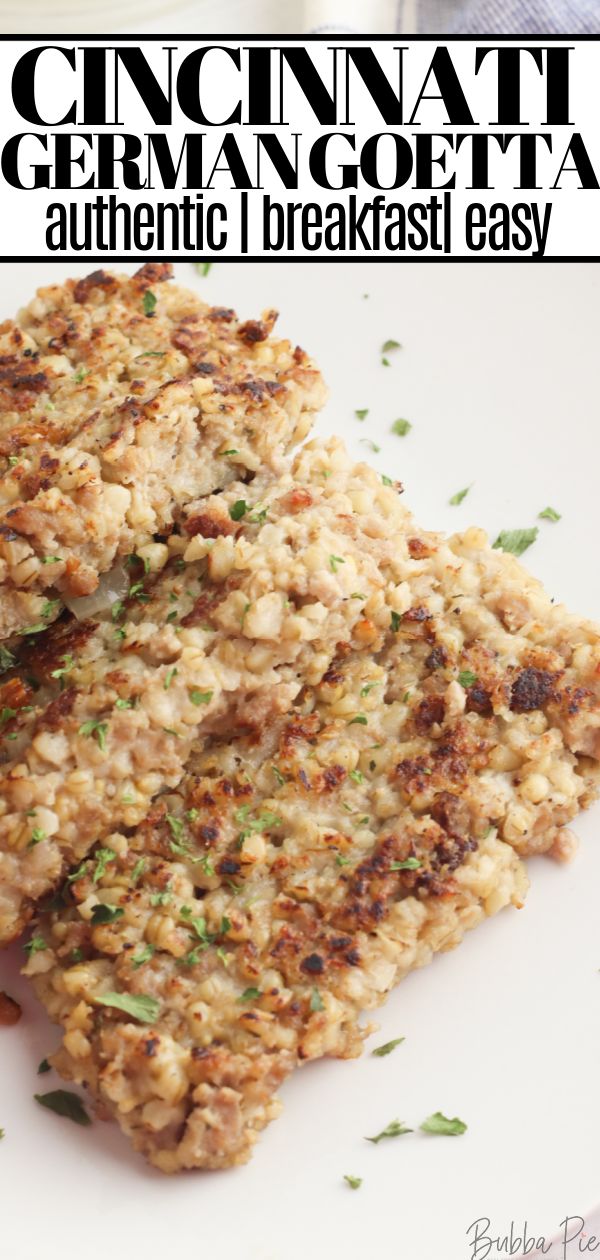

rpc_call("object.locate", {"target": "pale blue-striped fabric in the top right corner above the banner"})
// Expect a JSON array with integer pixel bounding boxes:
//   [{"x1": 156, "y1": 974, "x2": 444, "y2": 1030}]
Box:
[{"x1": 449, "y1": 0, "x2": 600, "y2": 35}]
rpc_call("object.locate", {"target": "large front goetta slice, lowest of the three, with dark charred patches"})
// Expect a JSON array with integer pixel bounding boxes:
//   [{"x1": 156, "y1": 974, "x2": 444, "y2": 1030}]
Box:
[{"x1": 25, "y1": 501, "x2": 600, "y2": 1172}]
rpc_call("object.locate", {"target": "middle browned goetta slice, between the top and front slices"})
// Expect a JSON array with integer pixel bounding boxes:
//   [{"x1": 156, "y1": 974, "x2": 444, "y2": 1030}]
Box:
[{"x1": 0, "y1": 440, "x2": 421, "y2": 942}]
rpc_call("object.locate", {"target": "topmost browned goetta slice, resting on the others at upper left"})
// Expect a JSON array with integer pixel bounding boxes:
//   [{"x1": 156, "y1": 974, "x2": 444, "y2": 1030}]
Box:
[{"x1": 0, "y1": 263, "x2": 325, "y2": 639}]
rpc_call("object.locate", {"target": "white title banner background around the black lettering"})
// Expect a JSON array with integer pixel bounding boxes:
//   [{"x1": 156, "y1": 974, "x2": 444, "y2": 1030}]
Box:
[{"x1": 0, "y1": 38, "x2": 600, "y2": 258}]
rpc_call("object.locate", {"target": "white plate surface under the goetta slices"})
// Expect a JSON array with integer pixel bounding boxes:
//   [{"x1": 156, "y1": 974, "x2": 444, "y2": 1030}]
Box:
[{"x1": 0, "y1": 263, "x2": 600, "y2": 1260}]
